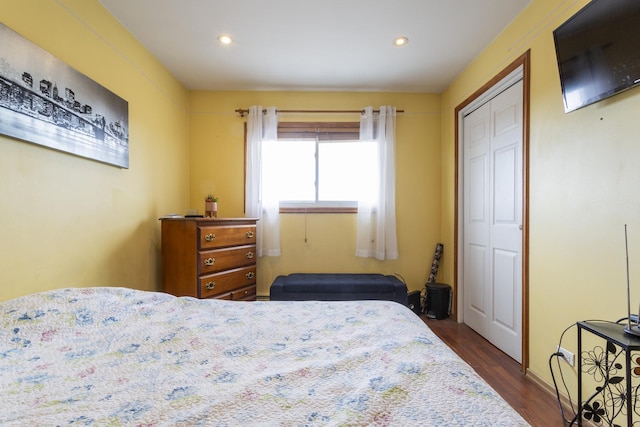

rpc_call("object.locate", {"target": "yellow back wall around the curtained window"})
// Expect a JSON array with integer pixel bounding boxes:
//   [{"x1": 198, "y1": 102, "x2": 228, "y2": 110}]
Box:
[{"x1": 189, "y1": 91, "x2": 448, "y2": 296}]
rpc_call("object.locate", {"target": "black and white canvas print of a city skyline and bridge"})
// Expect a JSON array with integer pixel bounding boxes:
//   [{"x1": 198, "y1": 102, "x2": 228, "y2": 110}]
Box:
[{"x1": 0, "y1": 23, "x2": 129, "y2": 168}]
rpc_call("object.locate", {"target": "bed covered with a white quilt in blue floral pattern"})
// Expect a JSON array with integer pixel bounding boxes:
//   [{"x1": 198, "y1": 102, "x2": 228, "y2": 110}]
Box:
[{"x1": 0, "y1": 288, "x2": 528, "y2": 427}]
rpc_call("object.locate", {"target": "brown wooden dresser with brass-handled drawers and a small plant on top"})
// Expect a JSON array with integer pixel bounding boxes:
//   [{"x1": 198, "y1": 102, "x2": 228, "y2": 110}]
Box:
[{"x1": 160, "y1": 218, "x2": 257, "y2": 301}]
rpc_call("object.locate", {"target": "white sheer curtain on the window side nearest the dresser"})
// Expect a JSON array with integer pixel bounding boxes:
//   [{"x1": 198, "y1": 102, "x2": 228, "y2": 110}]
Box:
[{"x1": 245, "y1": 105, "x2": 280, "y2": 257}]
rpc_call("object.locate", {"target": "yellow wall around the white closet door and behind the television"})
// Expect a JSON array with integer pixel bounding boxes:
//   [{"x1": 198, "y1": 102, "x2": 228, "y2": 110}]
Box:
[{"x1": 442, "y1": 0, "x2": 640, "y2": 390}]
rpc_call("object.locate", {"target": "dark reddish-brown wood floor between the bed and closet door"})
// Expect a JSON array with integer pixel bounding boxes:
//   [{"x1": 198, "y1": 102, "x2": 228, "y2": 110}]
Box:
[{"x1": 423, "y1": 317, "x2": 569, "y2": 427}]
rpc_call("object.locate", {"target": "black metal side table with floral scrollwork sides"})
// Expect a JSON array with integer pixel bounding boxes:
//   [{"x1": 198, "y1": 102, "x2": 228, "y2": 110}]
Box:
[{"x1": 577, "y1": 321, "x2": 640, "y2": 426}]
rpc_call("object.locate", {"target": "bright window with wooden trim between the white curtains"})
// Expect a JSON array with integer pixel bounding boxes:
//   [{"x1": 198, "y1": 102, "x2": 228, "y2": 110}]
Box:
[{"x1": 262, "y1": 122, "x2": 376, "y2": 212}]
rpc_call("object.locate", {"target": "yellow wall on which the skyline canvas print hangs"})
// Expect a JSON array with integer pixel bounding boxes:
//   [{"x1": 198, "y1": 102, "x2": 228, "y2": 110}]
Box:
[{"x1": 0, "y1": 0, "x2": 189, "y2": 300}]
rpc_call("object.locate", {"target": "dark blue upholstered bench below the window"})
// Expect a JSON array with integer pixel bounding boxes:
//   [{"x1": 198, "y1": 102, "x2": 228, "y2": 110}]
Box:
[{"x1": 269, "y1": 273, "x2": 407, "y2": 305}]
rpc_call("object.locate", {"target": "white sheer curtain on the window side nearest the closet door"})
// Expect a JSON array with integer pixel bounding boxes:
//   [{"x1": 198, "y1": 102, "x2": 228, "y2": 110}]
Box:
[{"x1": 356, "y1": 106, "x2": 398, "y2": 260}]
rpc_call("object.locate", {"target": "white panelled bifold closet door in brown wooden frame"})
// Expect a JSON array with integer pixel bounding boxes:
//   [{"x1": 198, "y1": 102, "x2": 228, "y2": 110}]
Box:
[{"x1": 462, "y1": 80, "x2": 523, "y2": 362}]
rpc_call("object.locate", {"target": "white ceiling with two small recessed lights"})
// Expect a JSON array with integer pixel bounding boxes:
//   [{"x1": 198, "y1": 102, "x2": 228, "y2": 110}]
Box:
[{"x1": 100, "y1": 0, "x2": 530, "y2": 93}]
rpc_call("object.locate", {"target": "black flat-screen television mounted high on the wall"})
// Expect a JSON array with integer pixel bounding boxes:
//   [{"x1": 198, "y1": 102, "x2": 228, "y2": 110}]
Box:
[{"x1": 553, "y1": 0, "x2": 640, "y2": 113}]
